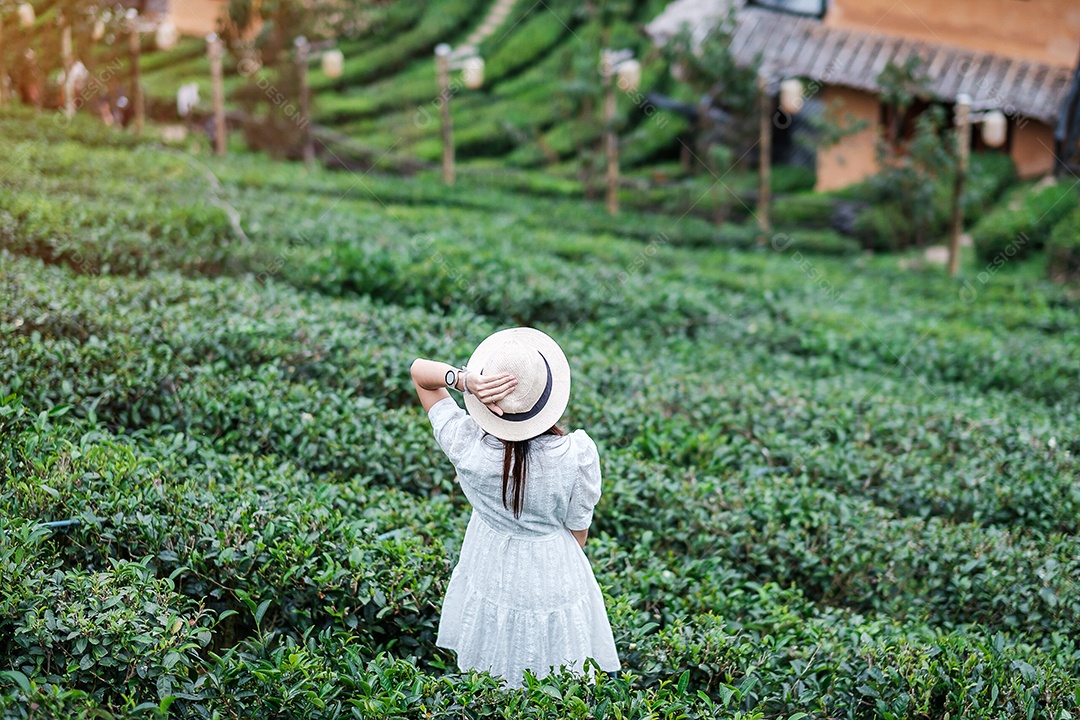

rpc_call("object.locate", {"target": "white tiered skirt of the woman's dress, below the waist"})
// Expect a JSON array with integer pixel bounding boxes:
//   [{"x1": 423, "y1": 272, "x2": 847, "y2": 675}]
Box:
[{"x1": 436, "y1": 512, "x2": 620, "y2": 687}]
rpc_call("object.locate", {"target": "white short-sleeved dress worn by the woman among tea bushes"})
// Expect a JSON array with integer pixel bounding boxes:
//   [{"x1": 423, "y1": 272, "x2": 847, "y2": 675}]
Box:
[{"x1": 428, "y1": 398, "x2": 620, "y2": 688}]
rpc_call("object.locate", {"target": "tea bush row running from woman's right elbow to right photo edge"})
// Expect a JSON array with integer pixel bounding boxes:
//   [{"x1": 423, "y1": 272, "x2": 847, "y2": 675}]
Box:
[{"x1": 596, "y1": 452, "x2": 1080, "y2": 651}]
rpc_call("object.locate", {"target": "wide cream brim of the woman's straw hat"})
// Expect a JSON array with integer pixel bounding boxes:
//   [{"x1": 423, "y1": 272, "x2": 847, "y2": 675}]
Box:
[{"x1": 464, "y1": 327, "x2": 570, "y2": 440}]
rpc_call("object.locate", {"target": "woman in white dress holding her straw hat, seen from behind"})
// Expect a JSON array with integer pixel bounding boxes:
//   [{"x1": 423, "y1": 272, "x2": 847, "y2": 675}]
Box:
[{"x1": 411, "y1": 327, "x2": 619, "y2": 688}]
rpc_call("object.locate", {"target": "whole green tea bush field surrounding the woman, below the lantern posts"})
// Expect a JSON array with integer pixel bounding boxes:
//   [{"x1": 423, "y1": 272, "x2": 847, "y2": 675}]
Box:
[{"x1": 0, "y1": 115, "x2": 1080, "y2": 720}]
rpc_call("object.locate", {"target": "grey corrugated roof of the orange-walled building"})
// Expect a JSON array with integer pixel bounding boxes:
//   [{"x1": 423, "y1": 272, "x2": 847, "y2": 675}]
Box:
[{"x1": 648, "y1": 0, "x2": 1072, "y2": 125}]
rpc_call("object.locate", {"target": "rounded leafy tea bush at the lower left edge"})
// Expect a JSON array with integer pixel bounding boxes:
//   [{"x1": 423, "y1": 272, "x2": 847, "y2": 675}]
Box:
[{"x1": 0, "y1": 524, "x2": 213, "y2": 705}]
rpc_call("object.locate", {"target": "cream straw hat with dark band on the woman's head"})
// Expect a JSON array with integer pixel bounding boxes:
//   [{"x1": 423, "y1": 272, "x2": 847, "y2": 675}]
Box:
[{"x1": 465, "y1": 327, "x2": 570, "y2": 440}]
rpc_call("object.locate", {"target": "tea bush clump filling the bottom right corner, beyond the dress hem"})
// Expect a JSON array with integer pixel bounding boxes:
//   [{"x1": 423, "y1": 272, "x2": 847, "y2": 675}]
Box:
[{"x1": 613, "y1": 584, "x2": 1076, "y2": 718}]
